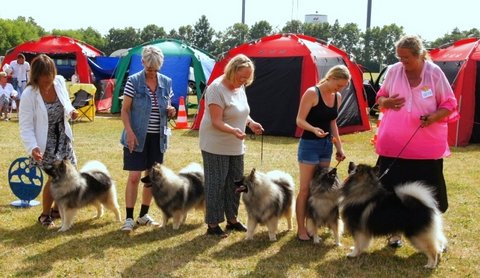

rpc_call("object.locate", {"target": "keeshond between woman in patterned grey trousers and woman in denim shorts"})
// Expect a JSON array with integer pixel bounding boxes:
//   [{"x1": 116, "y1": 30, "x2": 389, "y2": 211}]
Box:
[{"x1": 236, "y1": 169, "x2": 295, "y2": 241}]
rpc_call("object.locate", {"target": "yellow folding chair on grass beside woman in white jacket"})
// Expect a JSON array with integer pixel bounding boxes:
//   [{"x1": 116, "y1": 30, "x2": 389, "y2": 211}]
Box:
[{"x1": 70, "y1": 83, "x2": 97, "y2": 122}]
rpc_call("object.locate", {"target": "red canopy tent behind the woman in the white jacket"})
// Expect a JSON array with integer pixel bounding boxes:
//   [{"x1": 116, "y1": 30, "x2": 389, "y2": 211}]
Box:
[{"x1": 2, "y1": 36, "x2": 103, "y2": 83}]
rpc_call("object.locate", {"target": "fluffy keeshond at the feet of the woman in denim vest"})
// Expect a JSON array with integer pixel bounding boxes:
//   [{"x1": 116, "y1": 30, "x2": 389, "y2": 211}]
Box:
[{"x1": 142, "y1": 163, "x2": 205, "y2": 230}]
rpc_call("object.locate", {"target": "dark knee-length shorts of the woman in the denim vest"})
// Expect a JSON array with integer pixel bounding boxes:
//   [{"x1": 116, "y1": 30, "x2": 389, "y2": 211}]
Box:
[{"x1": 123, "y1": 133, "x2": 163, "y2": 171}]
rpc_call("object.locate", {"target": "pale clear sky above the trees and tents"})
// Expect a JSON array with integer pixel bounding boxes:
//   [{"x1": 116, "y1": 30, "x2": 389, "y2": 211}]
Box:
[{"x1": 0, "y1": 0, "x2": 480, "y2": 40}]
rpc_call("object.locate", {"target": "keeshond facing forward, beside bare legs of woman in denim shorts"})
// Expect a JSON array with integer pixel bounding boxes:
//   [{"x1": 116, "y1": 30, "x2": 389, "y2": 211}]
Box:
[{"x1": 306, "y1": 165, "x2": 343, "y2": 246}]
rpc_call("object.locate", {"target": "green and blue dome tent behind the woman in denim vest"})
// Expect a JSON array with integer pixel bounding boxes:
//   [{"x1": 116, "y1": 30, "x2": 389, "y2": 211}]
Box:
[{"x1": 111, "y1": 39, "x2": 215, "y2": 113}]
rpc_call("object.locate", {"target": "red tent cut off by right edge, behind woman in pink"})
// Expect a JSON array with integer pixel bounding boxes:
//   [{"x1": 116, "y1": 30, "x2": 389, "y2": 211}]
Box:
[{"x1": 430, "y1": 38, "x2": 480, "y2": 146}]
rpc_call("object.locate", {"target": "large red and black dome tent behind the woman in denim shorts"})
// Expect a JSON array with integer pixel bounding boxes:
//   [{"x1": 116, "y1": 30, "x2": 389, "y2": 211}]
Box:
[{"x1": 192, "y1": 34, "x2": 370, "y2": 137}]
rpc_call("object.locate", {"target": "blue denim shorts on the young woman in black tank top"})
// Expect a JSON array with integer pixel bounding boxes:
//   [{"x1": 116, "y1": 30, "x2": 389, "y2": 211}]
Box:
[{"x1": 297, "y1": 137, "x2": 333, "y2": 164}]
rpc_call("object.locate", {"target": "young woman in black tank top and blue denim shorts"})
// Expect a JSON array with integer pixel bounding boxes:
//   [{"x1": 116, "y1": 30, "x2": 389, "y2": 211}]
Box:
[{"x1": 296, "y1": 65, "x2": 350, "y2": 240}]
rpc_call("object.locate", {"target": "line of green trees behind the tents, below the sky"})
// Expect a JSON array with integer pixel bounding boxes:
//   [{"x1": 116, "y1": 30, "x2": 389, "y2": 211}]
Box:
[{"x1": 0, "y1": 15, "x2": 480, "y2": 71}]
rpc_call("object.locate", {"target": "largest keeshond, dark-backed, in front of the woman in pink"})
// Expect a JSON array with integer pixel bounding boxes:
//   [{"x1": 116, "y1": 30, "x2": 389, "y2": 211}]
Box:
[{"x1": 341, "y1": 162, "x2": 447, "y2": 268}]
